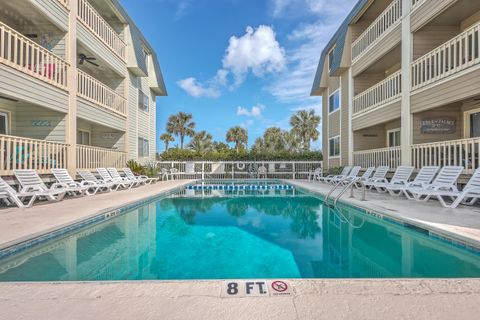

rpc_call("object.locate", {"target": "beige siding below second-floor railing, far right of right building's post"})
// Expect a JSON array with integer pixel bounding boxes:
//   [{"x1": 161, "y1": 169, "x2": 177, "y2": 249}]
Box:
[{"x1": 411, "y1": 65, "x2": 480, "y2": 113}]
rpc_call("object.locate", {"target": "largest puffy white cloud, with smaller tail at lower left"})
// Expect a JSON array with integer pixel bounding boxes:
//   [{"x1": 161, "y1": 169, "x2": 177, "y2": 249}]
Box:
[{"x1": 177, "y1": 25, "x2": 287, "y2": 98}]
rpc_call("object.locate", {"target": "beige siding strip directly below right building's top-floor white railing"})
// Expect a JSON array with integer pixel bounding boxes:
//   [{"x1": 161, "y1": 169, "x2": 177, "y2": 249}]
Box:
[{"x1": 352, "y1": 25, "x2": 402, "y2": 77}]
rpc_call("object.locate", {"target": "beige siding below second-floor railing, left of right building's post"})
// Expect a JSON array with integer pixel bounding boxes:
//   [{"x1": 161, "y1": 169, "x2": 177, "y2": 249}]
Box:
[{"x1": 352, "y1": 100, "x2": 401, "y2": 131}]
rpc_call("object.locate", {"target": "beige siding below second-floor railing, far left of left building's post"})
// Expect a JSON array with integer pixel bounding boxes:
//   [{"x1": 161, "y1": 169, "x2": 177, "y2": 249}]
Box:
[{"x1": 0, "y1": 64, "x2": 68, "y2": 112}]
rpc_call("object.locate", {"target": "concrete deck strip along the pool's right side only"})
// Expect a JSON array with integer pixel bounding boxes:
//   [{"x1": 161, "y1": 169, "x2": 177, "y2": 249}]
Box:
[{"x1": 285, "y1": 180, "x2": 480, "y2": 248}]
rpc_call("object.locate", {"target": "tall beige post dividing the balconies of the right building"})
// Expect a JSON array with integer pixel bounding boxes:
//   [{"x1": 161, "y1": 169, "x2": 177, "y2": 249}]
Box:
[{"x1": 400, "y1": 1, "x2": 413, "y2": 165}]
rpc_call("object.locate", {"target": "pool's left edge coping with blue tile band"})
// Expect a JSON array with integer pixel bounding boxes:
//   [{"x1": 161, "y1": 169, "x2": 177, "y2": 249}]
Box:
[{"x1": 0, "y1": 180, "x2": 191, "y2": 260}]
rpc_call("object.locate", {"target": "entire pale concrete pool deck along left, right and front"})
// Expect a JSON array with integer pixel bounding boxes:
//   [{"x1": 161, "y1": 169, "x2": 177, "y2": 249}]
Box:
[{"x1": 0, "y1": 180, "x2": 480, "y2": 320}]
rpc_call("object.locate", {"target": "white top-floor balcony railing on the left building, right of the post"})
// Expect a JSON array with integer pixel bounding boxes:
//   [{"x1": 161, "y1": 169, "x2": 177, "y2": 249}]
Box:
[{"x1": 78, "y1": 0, "x2": 125, "y2": 60}]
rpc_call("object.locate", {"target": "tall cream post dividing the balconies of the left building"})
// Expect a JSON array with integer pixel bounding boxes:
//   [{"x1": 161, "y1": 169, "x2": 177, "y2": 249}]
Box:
[{"x1": 65, "y1": 0, "x2": 78, "y2": 176}]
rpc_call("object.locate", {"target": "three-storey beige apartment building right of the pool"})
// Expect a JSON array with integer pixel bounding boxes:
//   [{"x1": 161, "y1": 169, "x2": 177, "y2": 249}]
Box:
[{"x1": 312, "y1": 0, "x2": 480, "y2": 173}]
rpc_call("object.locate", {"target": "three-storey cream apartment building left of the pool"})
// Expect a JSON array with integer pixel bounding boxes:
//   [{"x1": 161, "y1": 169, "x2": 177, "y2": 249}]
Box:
[{"x1": 0, "y1": 0, "x2": 166, "y2": 175}]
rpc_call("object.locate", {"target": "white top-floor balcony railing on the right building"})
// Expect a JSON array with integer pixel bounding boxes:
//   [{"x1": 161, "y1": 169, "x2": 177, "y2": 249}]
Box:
[{"x1": 352, "y1": 0, "x2": 402, "y2": 62}]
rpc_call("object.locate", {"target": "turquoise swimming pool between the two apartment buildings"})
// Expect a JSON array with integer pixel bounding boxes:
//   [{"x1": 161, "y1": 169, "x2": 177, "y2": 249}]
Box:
[{"x1": 0, "y1": 181, "x2": 480, "y2": 281}]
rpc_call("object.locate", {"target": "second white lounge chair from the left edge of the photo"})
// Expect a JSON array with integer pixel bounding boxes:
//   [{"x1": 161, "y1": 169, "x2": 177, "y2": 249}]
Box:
[{"x1": 13, "y1": 169, "x2": 67, "y2": 201}]
